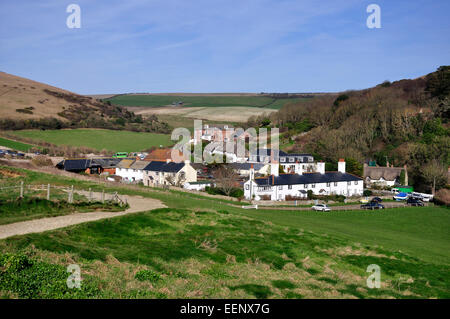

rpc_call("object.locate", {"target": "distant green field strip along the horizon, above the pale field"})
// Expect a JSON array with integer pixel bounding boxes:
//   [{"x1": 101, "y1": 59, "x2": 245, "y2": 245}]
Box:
[{"x1": 106, "y1": 94, "x2": 309, "y2": 109}]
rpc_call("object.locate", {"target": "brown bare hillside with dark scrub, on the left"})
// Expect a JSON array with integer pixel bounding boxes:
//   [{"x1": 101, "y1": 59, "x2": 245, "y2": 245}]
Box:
[{"x1": 0, "y1": 72, "x2": 168, "y2": 132}]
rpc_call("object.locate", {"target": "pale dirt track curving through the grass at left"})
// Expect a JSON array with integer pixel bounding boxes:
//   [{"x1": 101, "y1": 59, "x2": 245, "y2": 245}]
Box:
[{"x1": 0, "y1": 192, "x2": 167, "y2": 239}]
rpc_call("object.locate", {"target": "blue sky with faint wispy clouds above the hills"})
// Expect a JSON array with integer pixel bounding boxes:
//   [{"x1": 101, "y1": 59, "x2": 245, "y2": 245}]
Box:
[{"x1": 0, "y1": 0, "x2": 450, "y2": 94}]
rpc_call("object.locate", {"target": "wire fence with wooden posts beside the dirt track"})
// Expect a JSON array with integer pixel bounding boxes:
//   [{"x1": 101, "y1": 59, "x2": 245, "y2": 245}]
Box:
[{"x1": 0, "y1": 181, "x2": 127, "y2": 206}]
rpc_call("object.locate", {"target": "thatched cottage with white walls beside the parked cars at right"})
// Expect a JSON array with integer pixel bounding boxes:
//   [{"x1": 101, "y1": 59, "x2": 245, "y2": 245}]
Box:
[{"x1": 363, "y1": 163, "x2": 408, "y2": 186}]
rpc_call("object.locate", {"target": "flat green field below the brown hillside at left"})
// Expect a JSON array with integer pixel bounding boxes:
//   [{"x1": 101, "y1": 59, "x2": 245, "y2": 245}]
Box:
[{"x1": 10, "y1": 129, "x2": 174, "y2": 152}]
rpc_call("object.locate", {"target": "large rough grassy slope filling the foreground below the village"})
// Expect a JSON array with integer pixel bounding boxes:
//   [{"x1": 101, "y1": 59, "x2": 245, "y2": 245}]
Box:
[{"x1": 0, "y1": 167, "x2": 450, "y2": 298}]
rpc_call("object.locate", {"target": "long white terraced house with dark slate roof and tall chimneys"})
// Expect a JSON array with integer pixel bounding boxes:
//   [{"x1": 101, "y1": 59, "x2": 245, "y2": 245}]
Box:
[{"x1": 244, "y1": 159, "x2": 364, "y2": 200}]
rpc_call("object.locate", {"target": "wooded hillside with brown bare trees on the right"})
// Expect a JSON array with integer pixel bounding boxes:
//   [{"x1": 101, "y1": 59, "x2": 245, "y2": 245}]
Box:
[{"x1": 247, "y1": 66, "x2": 450, "y2": 191}]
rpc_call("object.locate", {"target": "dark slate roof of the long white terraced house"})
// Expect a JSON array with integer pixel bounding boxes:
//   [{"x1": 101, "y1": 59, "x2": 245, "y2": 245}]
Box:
[{"x1": 255, "y1": 172, "x2": 362, "y2": 186}]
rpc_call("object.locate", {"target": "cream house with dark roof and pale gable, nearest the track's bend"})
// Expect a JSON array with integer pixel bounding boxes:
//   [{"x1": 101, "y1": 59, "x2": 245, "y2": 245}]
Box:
[{"x1": 143, "y1": 161, "x2": 197, "y2": 187}]
